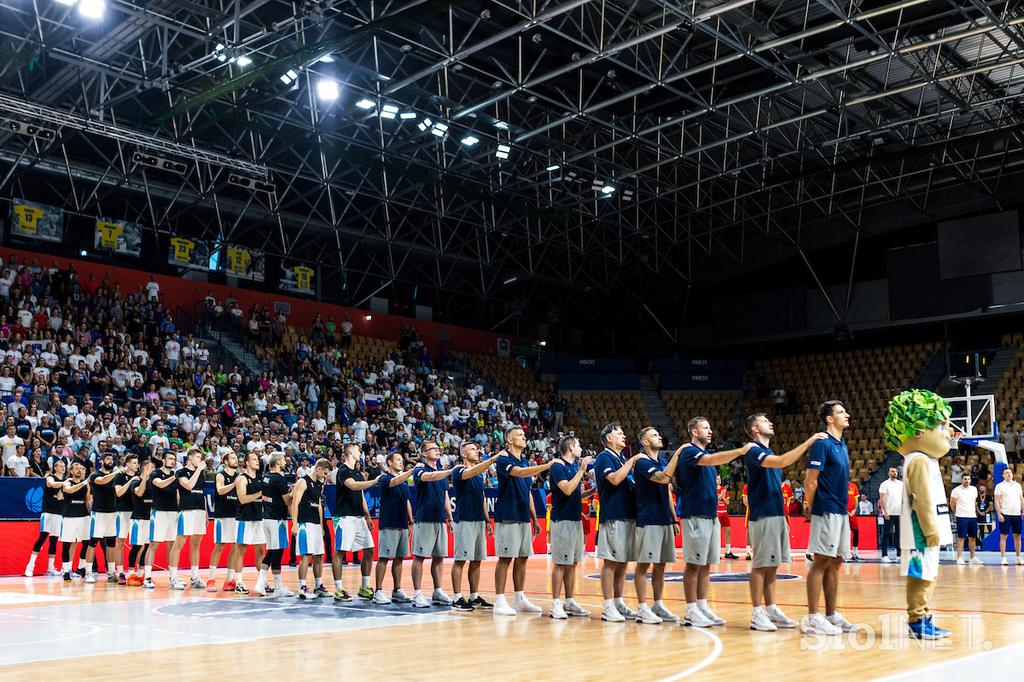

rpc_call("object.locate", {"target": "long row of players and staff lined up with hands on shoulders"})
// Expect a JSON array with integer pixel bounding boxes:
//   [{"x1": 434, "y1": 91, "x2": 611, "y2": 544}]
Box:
[{"x1": 24, "y1": 401, "x2": 853, "y2": 634}]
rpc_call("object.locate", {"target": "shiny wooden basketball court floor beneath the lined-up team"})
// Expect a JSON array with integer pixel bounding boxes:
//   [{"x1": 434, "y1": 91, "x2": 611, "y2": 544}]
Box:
[{"x1": 0, "y1": 556, "x2": 1024, "y2": 682}]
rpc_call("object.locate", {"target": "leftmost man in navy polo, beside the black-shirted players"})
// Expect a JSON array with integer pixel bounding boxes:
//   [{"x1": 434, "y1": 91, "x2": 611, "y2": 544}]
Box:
[{"x1": 372, "y1": 451, "x2": 413, "y2": 604}]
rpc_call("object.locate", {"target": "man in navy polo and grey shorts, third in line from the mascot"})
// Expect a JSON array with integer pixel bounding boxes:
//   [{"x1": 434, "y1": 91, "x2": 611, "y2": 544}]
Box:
[{"x1": 676, "y1": 417, "x2": 753, "y2": 628}]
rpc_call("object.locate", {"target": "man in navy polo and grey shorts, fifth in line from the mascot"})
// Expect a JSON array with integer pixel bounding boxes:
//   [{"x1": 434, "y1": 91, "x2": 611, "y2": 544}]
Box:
[{"x1": 594, "y1": 422, "x2": 643, "y2": 623}]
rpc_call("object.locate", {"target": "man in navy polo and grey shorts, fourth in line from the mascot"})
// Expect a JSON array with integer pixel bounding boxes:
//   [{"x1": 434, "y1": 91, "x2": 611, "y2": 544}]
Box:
[{"x1": 633, "y1": 426, "x2": 679, "y2": 625}]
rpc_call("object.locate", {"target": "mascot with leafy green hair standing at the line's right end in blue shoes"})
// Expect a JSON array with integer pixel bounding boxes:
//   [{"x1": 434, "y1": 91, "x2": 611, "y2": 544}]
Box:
[{"x1": 886, "y1": 389, "x2": 956, "y2": 639}]
